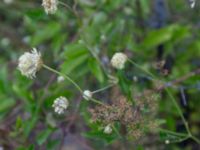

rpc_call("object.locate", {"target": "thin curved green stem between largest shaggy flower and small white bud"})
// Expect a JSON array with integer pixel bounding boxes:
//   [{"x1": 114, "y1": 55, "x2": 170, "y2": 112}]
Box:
[{"x1": 43, "y1": 64, "x2": 83, "y2": 93}]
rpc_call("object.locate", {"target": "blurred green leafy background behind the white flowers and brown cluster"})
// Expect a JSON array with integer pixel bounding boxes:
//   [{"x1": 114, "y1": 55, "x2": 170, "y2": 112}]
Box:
[{"x1": 0, "y1": 0, "x2": 200, "y2": 150}]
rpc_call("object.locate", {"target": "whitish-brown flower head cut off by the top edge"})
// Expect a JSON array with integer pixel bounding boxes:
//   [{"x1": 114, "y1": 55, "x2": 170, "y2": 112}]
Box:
[{"x1": 42, "y1": 0, "x2": 58, "y2": 14}]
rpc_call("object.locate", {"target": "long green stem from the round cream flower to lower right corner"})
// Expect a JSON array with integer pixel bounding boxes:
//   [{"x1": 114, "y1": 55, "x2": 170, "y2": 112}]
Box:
[{"x1": 128, "y1": 59, "x2": 200, "y2": 144}]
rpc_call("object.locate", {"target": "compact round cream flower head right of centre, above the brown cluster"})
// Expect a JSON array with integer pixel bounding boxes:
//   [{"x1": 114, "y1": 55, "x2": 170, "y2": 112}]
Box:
[{"x1": 111, "y1": 52, "x2": 128, "y2": 69}]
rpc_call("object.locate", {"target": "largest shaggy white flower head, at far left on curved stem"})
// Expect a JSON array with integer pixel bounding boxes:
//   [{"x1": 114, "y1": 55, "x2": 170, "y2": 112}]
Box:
[{"x1": 18, "y1": 48, "x2": 42, "y2": 79}]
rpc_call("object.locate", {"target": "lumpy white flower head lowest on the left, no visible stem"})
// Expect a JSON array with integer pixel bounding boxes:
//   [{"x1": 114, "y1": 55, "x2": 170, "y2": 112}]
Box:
[{"x1": 52, "y1": 96, "x2": 69, "y2": 114}]
